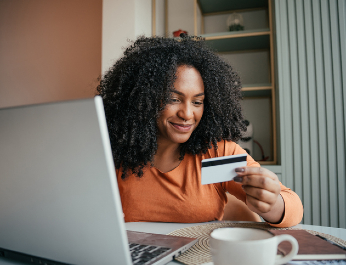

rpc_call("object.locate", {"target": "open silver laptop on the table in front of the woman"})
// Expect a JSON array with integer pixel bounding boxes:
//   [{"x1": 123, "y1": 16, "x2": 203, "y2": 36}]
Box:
[{"x1": 0, "y1": 96, "x2": 196, "y2": 265}]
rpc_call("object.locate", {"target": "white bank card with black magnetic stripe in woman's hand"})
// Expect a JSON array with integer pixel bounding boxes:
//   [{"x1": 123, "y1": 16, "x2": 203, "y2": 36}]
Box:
[{"x1": 202, "y1": 154, "x2": 247, "y2": 185}]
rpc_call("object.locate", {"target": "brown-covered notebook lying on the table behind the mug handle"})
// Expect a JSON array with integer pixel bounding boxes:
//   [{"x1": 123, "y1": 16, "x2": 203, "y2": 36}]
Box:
[{"x1": 270, "y1": 230, "x2": 346, "y2": 260}]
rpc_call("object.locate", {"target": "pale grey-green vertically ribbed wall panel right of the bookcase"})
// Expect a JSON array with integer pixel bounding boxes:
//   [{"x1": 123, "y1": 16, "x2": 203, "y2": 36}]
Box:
[{"x1": 273, "y1": 0, "x2": 346, "y2": 228}]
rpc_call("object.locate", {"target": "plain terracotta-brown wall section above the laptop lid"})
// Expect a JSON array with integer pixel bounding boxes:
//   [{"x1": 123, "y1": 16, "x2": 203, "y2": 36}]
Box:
[{"x1": 0, "y1": 0, "x2": 102, "y2": 107}]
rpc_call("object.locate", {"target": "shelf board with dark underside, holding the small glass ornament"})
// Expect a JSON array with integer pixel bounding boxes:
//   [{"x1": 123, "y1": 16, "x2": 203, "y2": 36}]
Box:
[{"x1": 201, "y1": 29, "x2": 270, "y2": 52}]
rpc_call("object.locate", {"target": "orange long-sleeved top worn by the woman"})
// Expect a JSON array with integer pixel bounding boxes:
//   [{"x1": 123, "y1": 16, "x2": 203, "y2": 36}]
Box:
[{"x1": 116, "y1": 141, "x2": 303, "y2": 227}]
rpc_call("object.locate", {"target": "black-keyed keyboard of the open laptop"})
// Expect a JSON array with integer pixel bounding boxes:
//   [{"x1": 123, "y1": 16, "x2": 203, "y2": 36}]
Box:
[{"x1": 129, "y1": 243, "x2": 171, "y2": 265}]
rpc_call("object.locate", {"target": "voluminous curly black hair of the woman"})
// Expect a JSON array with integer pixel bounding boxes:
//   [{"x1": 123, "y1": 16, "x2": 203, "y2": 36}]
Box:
[{"x1": 97, "y1": 36, "x2": 246, "y2": 179}]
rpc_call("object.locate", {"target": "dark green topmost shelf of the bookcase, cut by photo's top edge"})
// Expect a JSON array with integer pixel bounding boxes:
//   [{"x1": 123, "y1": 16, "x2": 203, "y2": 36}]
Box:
[{"x1": 198, "y1": 0, "x2": 268, "y2": 15}]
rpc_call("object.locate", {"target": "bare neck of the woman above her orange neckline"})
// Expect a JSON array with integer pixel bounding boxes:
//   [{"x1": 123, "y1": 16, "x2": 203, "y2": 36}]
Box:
[{"x1": 154, "y1": 141, "x2": 181, "y2": 173}]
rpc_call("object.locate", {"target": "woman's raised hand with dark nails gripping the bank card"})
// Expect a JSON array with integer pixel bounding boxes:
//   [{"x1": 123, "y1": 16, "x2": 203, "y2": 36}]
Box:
[{"x1": 234, "y1": 167, "x2": 285, "y2": 223}]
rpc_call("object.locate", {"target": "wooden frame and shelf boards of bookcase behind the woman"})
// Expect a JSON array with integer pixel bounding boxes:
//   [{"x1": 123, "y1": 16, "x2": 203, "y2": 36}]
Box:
[{"x1": 194, "y1": 0, "x2": 277, "y2": 165}]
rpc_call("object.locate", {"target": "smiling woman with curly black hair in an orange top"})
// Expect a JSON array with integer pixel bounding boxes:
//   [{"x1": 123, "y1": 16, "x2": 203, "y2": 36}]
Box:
[{"x1": 98, "y1": 36, "x2": 303, "y2": 227}]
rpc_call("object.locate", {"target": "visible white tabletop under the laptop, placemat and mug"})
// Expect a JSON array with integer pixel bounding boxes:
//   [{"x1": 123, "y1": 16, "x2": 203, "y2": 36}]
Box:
[{"x1": 0, "y1": 222, "x2": 346, "y2": 265}]
